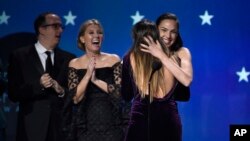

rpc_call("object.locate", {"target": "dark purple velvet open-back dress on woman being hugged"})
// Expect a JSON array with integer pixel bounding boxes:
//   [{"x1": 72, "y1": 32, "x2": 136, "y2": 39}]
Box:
[{"x1": 121, "y1": 55, "x2": 182, "y2": 141}]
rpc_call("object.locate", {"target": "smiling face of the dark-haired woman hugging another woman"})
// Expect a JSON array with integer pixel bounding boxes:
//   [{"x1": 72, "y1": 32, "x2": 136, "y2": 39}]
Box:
[{"x1": 158, "y1": 19, "x2": 178, "y2": 47}]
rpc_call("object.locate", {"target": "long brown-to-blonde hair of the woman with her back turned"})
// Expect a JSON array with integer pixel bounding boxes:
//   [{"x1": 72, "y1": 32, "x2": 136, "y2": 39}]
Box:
[{"x1": 129, "y1": 20, "x2": 170, "y2": 102}]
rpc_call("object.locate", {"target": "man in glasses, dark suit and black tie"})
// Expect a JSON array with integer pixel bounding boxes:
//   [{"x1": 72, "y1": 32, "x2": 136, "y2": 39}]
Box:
[{"x1": 8, "y1": 12, "x2": 75, "y2": 141}]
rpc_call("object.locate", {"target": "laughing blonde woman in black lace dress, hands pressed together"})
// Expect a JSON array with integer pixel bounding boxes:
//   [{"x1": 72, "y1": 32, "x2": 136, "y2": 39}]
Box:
[{"x1": 64, "y1": 19, "x2": 123, "y2": 141}]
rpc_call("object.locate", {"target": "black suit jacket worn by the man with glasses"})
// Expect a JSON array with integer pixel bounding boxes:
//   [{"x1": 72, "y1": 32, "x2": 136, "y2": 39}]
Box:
[{"x1": 8, "y1": 45, "x2": 75, "y2": 141}]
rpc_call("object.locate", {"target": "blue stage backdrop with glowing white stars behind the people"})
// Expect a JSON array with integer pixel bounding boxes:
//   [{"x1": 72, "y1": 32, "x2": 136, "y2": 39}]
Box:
[{"x1": 0, "y1": 0, "x2": 250, "y2": 141}]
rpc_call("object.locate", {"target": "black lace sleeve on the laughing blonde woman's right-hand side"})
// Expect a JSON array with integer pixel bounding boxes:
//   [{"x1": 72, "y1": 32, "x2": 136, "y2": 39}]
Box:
[{"x1": 108, "y1": 62, "x2": 122, "y2": 99}]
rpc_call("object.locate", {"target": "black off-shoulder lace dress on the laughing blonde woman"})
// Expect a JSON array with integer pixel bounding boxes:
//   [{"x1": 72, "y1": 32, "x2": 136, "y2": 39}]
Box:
[{"x1": 63, "y1": 63, "x2": 124, "y2": 141}]
